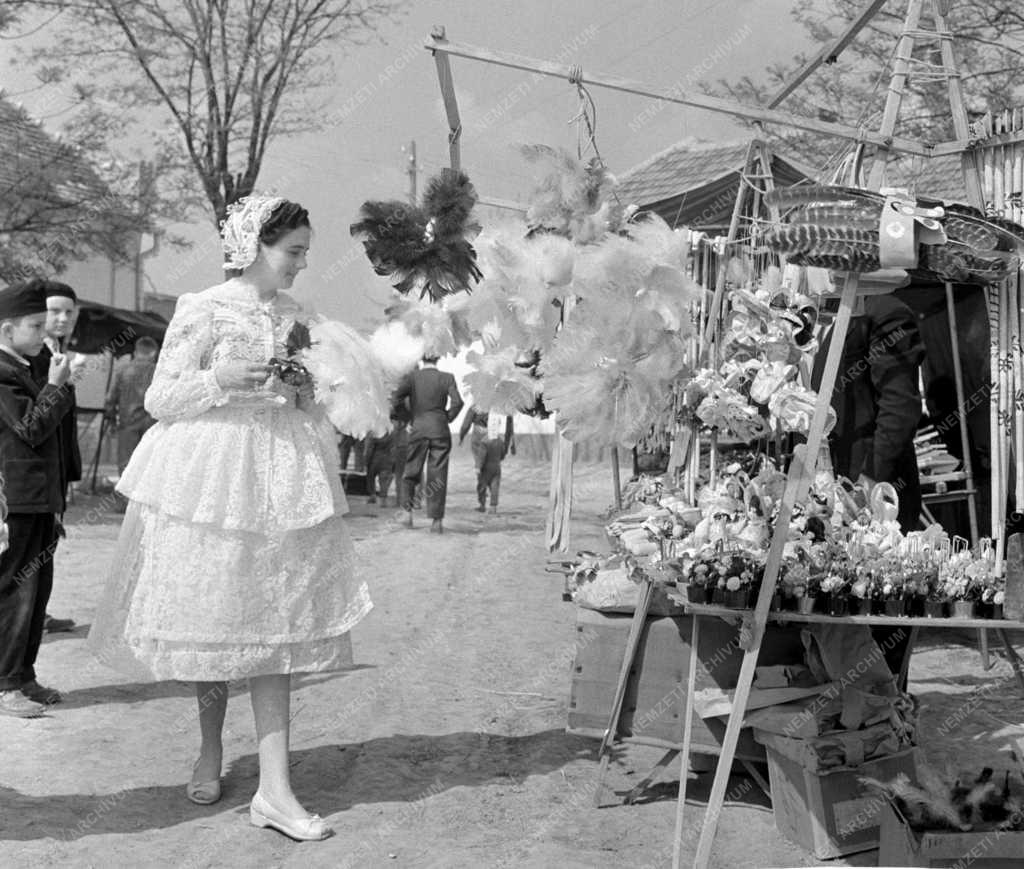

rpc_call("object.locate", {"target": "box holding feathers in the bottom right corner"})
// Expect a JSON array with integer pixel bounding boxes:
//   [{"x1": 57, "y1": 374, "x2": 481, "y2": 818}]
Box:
[{"x1": 879, "y1": 802, "x2": 1024, "y2": 869}]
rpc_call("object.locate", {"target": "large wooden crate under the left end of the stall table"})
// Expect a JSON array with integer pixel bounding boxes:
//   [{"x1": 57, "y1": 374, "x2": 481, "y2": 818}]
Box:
[{"x1": 566, "y1": 607, "x2": 803, "y2": 762}]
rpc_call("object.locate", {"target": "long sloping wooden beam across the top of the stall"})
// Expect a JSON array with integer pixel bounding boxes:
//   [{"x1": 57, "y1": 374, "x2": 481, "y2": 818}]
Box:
[{"x1": 423, "y1": 36, "x2": 932, "y2": 157}]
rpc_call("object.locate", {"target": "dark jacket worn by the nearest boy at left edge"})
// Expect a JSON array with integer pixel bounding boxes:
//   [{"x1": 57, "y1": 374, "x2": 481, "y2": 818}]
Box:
[{"x1": 0, "y1": 351, "x2": 75, "y2": 513}]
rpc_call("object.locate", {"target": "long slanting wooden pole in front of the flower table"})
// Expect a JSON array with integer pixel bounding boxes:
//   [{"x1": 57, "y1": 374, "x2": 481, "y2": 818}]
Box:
[{"x1": 693, "y1": 272, "x2": 859, "y2": 869}]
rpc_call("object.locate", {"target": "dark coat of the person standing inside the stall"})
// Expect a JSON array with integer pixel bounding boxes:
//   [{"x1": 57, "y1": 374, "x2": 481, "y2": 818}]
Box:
[{"x1": 814, "y1": 296, "x2": 925, "y2": 531}]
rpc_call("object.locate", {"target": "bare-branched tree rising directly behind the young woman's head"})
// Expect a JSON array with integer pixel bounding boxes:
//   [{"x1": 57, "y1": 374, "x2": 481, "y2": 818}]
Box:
[{"x1": 12, "y1": 0, "x2": 404, "y2": 224}]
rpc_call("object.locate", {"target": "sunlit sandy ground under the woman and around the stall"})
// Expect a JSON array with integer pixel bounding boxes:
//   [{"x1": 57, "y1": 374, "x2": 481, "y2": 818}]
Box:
[{"x1": 0, "y1": 449, "x2": 1024, "y2": 869}]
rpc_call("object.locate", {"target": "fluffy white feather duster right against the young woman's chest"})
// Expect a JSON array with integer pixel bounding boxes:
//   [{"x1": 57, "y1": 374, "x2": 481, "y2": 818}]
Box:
[{"x1": 302, "y1": 319, "x2": 391, "y2": 438}]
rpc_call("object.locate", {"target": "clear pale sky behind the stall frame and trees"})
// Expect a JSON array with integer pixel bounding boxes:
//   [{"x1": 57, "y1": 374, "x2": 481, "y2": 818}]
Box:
[{"x1": 0, "y1": 0, "x2": 807, "y2": 325}]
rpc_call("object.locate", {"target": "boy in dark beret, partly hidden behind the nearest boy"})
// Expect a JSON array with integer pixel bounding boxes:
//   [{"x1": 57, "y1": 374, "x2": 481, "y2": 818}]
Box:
[{"x1": 29, "y1": 278, "x2": 82, "y2": 634}]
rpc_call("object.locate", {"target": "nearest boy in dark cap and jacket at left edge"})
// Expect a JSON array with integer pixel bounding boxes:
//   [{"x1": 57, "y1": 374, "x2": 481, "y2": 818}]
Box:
[{"x1": 0, "y1": 281, "x2": 74, "y2": 718}]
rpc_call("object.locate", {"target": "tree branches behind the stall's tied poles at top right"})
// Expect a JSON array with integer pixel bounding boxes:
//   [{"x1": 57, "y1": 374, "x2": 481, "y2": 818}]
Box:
[{"x1": 716, "y1": 0, "x2": 1024, "y2": 165}]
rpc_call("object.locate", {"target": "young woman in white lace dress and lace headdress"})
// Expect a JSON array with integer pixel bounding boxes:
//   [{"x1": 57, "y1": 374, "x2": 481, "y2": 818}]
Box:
[{"x1": 89, "y1": 195, "x2": 372, "y2": 839}]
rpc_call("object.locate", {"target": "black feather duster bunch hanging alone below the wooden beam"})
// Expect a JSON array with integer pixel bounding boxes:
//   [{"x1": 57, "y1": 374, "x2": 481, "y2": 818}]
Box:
[{"x1": 349, "y1": 169, "x2": 481, "y2": 301}]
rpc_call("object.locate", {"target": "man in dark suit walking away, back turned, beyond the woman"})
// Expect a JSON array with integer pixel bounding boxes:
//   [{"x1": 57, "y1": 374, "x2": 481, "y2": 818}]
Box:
[{"x1": 393, "y1": 356, "x2": 463, "y2": 534}]
